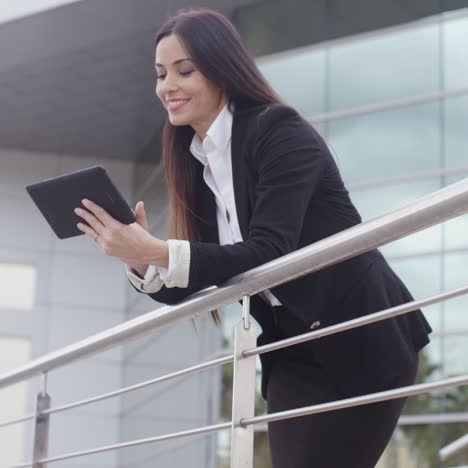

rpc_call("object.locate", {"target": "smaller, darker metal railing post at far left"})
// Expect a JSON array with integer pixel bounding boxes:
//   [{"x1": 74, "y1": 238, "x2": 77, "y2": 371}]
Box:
[{"x1": 33, "y1": 372, "x2": 50, "y2": 468}]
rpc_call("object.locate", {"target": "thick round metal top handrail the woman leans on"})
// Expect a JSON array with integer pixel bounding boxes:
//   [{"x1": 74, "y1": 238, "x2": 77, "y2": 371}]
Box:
[{"x1": 0, "y1": 179, "x2": 468, "y2": 387}]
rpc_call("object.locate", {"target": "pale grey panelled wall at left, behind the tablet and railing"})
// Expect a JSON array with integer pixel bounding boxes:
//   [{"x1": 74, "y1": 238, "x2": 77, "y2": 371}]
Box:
[{"x1": 0, "y1": 150, "x2": 133, "y2": 468}]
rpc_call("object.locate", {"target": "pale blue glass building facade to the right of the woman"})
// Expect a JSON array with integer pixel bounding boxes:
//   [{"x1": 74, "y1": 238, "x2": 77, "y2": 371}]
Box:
[{"x1": 218, "y1": 6, "x2": 468, "y2": 468}]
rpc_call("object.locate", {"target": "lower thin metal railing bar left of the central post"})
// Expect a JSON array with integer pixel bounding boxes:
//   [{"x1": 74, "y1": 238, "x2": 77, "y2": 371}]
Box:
[{"x1": 8, "y1": 422, "x2": 232, "y2": 468}]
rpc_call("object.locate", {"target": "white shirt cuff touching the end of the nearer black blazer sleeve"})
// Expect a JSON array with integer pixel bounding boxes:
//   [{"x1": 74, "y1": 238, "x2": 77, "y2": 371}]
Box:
[{"x1": 158, "y1": 239, "x2": 190, "y2": 288}]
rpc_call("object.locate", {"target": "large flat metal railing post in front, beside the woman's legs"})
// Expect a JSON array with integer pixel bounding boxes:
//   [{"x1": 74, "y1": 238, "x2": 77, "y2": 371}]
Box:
[{"x1": 231, "y1": 296, "x2": 257, "y2": 468}]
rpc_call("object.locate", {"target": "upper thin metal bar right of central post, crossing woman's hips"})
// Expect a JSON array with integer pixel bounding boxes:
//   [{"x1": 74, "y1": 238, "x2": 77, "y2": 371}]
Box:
[{"x1": 242, "y1": 286, "x2": 468, "y2": 358}]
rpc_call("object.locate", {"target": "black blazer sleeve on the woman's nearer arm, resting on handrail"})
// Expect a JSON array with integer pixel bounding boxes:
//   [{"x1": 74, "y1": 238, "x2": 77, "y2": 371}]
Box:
[{"x1": 188, "y1": 105, "x2": 331, "y2": 290}]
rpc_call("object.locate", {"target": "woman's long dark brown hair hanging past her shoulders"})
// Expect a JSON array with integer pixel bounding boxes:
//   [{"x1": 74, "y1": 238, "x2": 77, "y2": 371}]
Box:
[{"x1": 156, "y1": 8, "x2": 281, "y2": 322}]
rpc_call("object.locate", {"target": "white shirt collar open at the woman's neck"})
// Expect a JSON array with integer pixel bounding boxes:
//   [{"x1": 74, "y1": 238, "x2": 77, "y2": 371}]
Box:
[{"x1": 190, "y1": 103, "x2": 233, "y2": 166}]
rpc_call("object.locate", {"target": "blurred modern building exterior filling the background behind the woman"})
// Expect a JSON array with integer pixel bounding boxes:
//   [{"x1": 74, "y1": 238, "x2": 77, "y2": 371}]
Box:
[{"x1": 0, "y1": 0, "x2": 468, "y2": 468}]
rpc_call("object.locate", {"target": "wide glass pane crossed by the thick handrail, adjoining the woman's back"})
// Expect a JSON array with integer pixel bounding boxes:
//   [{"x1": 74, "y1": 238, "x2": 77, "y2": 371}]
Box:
[{"x1": 351, "y1": 178, "x2": 442, "y2": 255}]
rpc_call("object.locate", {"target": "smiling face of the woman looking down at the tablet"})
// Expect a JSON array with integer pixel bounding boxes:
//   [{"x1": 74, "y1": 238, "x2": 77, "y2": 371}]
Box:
[{"x1": 155, "y1": 34, "x2": 227, "y2": 138}]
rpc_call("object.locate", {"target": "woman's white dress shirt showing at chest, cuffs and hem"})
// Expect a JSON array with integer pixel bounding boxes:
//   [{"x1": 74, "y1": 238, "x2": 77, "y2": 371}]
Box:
[{"x1": 126, "y1": 104, "x2": 281, "y2": 306}]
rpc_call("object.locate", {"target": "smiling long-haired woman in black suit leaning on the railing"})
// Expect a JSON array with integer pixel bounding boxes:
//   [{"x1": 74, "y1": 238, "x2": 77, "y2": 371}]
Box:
[{"x1": 76, "y1": 10, "x2": 430, "y2": 468}]
